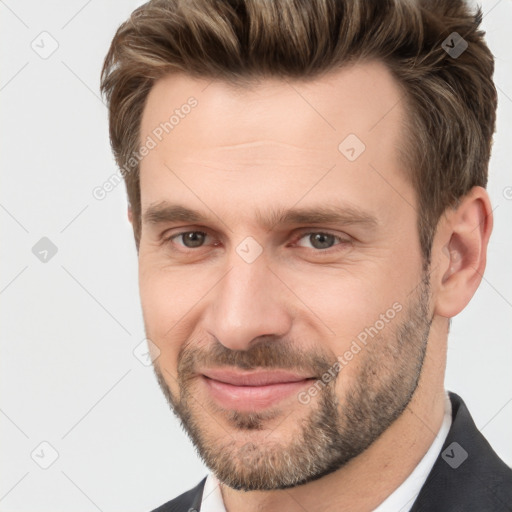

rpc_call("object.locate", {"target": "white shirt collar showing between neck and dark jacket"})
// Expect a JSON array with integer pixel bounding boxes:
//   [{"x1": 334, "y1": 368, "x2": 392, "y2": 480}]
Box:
[{"x1": 201, "y1": 392, "x2": 452, "y2": 512}]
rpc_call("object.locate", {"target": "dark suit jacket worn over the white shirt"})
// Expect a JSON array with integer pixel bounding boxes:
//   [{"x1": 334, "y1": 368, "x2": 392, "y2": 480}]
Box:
[{"x1": 153, "y1": 392, "x2": 512, "y2": 512}]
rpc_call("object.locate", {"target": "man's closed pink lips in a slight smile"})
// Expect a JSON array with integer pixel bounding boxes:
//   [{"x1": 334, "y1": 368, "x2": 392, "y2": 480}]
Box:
[{"x1": 200, "y1": 369, "x2": 316, "y2": 412}]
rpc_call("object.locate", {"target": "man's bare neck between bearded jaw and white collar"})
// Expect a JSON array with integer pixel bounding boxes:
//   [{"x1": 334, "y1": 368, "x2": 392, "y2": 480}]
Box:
[{"x1": 220, "y1": 324, "x2": 446, "y2": 512}]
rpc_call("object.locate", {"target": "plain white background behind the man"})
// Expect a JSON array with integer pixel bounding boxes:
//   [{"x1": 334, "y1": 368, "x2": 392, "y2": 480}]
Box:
[{"x1": 0, "y1": 0, "x2": 512, "y2": 512}]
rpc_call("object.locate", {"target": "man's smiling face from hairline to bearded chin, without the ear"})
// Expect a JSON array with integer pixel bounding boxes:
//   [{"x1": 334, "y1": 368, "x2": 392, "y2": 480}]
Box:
[{"x1": 135, "y1": 63, "x2": 432, "y2": 490}]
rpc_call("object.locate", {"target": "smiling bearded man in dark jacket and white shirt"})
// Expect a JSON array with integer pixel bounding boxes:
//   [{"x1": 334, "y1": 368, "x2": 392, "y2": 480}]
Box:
[{"x1": 102, "y1": 0, "x2": 512, "y2": 512}]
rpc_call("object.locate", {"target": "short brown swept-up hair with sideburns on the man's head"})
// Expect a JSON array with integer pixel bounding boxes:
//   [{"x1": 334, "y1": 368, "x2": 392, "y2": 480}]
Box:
[{"x1": 101, "y1": 0, "x2": 497, "y2": 262}]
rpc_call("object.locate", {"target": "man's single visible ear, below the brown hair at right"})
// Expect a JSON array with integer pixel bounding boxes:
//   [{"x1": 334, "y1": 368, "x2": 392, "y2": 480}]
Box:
[{"x1": 432, "y1": 187, "x2": 493, "y2": 318}]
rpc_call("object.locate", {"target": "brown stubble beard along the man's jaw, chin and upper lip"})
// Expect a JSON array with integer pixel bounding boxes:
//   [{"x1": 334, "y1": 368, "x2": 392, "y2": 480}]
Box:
[{"x1": 154, "y1": 273, "x2": 432, "y2": 491}]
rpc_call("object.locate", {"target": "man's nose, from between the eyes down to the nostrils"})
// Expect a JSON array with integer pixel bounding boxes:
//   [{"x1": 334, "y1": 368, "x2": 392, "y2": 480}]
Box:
[{"x1": 204, "y1": 254, "x2": 291, "y2": 350}]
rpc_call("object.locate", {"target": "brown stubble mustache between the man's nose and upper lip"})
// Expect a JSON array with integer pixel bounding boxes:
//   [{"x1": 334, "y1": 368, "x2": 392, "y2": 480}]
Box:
[{"x1": 178, "y1": 336, "x2": 337, "y2": 380}]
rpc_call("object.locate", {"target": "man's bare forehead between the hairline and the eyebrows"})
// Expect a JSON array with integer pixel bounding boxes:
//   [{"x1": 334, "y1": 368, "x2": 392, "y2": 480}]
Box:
[{"x1": 140, "y1": 62, "x2": 412, "y2": 227}]
